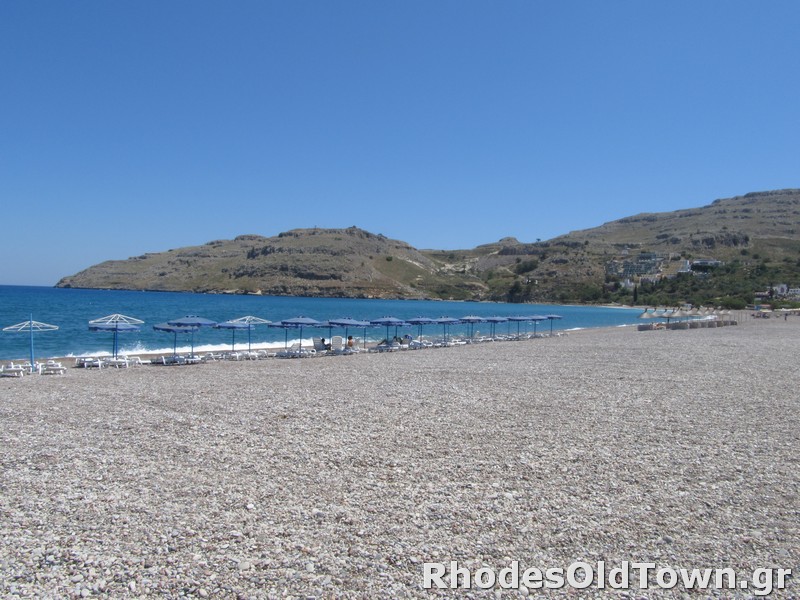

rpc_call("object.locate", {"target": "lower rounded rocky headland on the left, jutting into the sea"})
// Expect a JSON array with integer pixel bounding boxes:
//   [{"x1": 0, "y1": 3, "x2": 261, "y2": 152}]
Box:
[{"x1": 57, "y1": 227, "x2": 488, "y2": 298}]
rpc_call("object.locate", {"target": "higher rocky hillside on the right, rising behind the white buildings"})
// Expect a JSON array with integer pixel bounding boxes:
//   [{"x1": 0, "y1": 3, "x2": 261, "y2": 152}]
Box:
[{"x1": 428, "y1": 189, "x2": 800, "y2": 302}]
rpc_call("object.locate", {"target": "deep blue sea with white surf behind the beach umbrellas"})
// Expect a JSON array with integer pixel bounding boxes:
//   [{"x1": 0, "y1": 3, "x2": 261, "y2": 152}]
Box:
[{"x1": 0, "y1": 286, "x2": 641, "y2": 360}]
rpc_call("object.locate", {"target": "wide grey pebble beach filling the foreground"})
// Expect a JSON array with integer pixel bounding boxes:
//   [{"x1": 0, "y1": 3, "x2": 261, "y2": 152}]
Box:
[{"x1": 0, "y1": 317, "x2": 800, "y2": 598}]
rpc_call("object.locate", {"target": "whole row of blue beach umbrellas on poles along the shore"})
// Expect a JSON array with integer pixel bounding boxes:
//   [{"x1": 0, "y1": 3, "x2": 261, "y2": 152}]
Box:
[{"x1": 3, "y1": 314, "x2": 561, "y2": 365}]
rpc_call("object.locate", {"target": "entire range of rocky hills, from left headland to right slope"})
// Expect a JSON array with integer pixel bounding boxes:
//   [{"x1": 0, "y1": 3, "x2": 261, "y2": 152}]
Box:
[{"x1": 57, "y1": 189, "x2": 800, "y2": 302}]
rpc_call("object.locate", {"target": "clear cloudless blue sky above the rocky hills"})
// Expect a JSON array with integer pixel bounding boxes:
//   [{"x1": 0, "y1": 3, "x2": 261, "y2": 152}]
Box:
[{"x1": 0, "y1": 0, "x2": 800, "y2": 285}]
